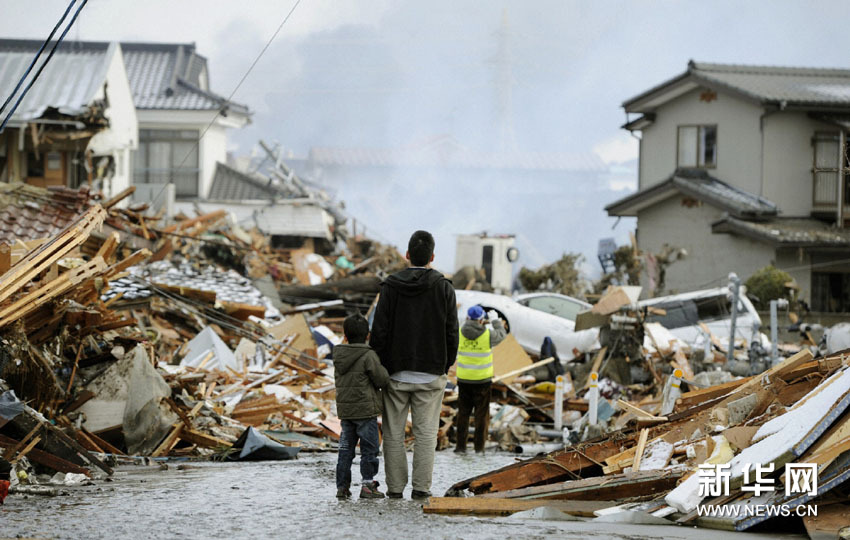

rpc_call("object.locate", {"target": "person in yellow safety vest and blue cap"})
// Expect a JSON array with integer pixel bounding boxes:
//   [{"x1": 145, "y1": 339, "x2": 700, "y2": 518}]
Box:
[{"x1": 455, "y1": 306, "x2": 507, "y2": 454}]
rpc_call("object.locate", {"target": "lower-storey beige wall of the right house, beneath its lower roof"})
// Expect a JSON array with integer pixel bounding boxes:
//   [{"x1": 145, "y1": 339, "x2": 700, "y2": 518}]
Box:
[{"x1": 638, "y1": 195, "x2": 775, "y2": 293}]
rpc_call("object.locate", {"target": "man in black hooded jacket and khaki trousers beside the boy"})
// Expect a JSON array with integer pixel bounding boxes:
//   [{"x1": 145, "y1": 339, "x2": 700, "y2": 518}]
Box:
[{"x1": 369, "y1": 231, "x2": 458, "y2": 500}]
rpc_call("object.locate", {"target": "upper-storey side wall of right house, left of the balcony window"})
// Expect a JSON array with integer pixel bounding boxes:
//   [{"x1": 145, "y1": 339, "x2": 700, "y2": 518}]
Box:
[{"x1": 763, "y1": 111, "x2": 838, "y2": 217}]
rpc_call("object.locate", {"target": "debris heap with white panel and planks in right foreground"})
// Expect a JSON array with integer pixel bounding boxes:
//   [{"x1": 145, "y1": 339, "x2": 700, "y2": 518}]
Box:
[{"x1": 425, "y1": 350, "x2": 850, "y2": 530}]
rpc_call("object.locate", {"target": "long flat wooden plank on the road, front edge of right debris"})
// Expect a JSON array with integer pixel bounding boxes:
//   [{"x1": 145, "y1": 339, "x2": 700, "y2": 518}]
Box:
[{"x1": 422, "y1": 497, "x2": 617, "y2": 518}]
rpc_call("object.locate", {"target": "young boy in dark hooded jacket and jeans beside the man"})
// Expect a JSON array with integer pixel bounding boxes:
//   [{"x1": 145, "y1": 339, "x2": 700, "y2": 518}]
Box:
[{"x1": 333, "y1": 314, "x2": 390, "y2": 499}]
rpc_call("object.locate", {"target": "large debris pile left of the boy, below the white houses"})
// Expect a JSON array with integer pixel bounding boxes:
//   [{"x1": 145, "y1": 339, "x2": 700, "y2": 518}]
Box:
[{"x1": 0, "y1": 182, "x2": 403, "y2": 493}]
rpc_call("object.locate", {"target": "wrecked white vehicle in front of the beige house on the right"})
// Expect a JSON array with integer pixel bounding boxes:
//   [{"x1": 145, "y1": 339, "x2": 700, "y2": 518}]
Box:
[{"x1": 638, "y1": 286, "x2": 766, "y2": 345}]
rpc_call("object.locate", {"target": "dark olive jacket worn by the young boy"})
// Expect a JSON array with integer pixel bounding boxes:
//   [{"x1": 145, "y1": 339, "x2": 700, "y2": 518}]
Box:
[{"x1": 334, "y1": 343, "x2": 390, "y2": 420}]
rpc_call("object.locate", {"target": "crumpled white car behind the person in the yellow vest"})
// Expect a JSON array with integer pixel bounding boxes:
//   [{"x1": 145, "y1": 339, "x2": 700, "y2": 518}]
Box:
[{"x1": 455, "y1": 290, "x2": 599, "y2": 361}]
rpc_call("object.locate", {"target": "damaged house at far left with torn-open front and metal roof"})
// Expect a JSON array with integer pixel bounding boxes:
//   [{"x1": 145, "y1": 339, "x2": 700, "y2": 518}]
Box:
[{"x1": 0, "y1": 39, "x2": 138, "y2": 197}]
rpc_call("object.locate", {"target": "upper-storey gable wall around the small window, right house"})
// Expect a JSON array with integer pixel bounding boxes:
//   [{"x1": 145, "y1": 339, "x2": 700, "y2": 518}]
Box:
[{"x1": 639, "y1": 89, "x2": 762, "y2": 193}]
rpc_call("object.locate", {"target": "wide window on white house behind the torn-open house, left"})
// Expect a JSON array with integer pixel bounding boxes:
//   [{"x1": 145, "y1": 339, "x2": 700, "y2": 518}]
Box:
[{"x1": 133, "y1": 129, "x2": 200, "y2": 197}]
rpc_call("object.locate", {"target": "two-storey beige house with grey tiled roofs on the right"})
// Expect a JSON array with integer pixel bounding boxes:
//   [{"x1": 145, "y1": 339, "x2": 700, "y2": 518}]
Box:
[{"x1": 606, "y1": 61, "x2": 850, "y2": 312}]
